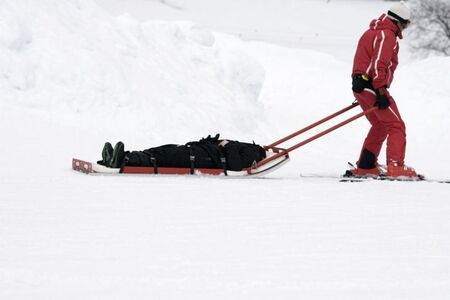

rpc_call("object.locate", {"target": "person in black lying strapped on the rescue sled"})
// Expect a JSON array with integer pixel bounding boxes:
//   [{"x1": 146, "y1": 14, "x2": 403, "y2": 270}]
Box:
[{"x1": 97, "y1": 134, "x2": 266, "y2": 171}]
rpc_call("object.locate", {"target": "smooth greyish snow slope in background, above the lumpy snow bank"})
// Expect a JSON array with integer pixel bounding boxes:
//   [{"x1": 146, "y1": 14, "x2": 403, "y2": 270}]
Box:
[{"x1": 95, "y1": 0, "x2": 390, "y2": 62}]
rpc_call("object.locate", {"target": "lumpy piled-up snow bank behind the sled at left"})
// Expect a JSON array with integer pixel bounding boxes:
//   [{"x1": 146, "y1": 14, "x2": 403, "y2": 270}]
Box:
[{"x1": 0, "y1": 0, "x2": 264, "y2": 143}]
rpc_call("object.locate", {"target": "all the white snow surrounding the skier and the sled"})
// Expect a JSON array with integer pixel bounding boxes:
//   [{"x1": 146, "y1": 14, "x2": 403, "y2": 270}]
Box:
[{"x1": 0, "y1": 0, "x2": 450, "y2": 299}]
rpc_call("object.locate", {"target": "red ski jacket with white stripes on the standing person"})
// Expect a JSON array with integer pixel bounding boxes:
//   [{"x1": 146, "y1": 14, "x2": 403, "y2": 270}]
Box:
[{"x1": 352, "y1": 14, "x2": 403, "y2": 89}]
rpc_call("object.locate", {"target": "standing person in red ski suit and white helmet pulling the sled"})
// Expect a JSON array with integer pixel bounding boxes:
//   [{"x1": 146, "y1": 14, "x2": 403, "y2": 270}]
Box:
[{"x1": 351, "y1": 2, "x2": 417, "y2": 178}]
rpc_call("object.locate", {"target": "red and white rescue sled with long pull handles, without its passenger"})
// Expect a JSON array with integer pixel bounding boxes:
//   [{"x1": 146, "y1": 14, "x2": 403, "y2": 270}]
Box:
[{"x1": 72, "y1": 101, "x2": 377, "y2": 177}]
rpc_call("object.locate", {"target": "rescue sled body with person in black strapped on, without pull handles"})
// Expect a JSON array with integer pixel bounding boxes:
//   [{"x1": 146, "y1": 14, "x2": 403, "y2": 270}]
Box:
[{"x1": 72, "y1": 134, "x2": 289, "y2": 176}]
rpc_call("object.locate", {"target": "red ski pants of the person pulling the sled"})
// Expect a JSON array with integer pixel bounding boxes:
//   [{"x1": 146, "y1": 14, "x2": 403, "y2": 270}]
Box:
[{"x1": 354, "y1": 89, "x2": 406, "y2": 165}]
